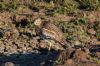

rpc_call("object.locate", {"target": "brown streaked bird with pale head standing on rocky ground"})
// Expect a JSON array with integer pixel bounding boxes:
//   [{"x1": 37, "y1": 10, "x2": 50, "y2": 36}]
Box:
[{"x1": 34, "y1": 18, "x2": 70, "y2": 50}]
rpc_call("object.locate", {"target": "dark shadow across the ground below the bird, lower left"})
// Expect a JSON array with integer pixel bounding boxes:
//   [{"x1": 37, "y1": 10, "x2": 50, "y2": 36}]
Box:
[{"x1": 0, "y1": 50, "x2": 59, "y2": 66}]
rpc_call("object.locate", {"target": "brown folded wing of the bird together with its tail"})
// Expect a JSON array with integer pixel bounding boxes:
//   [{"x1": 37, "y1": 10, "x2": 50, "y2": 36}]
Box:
[{"x1": 42, "y1": 23, "x2": 70, "y2": 47}]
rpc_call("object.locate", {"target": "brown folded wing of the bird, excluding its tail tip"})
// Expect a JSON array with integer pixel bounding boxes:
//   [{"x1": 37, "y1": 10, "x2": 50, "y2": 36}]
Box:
[{"x1": 42, "y1": 23, "x2": 64, "y2": 41}]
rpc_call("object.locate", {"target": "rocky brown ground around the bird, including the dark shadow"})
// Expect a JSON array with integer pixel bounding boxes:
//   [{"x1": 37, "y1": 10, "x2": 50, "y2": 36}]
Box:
[{"x1": 0, "y1": 0, "x2": 100, "y2": 66}]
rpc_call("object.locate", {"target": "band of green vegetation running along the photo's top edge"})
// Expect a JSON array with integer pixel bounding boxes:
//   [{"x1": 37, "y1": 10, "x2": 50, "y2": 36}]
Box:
[{"x1": 0, "y1": 0, "x2": 100, "y2": 12}]
